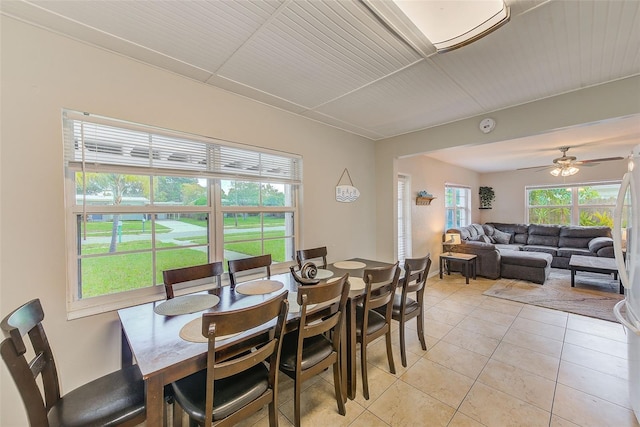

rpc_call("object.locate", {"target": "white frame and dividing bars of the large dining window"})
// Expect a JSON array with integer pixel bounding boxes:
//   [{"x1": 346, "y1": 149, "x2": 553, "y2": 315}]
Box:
[{"x1": 63, "y1": 110, "x2": 302, "y2": 319}]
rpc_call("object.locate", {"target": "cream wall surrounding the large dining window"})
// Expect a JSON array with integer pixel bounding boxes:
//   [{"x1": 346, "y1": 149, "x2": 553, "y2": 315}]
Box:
[{"x1": 0, "y1": 16, "x2": 376, "y2": 427}]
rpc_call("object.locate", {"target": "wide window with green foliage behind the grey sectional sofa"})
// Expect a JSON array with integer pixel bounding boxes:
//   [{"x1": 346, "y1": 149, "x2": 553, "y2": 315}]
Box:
[{"x1": 525, "y1": 181, "x2": 620, "y2": 227}]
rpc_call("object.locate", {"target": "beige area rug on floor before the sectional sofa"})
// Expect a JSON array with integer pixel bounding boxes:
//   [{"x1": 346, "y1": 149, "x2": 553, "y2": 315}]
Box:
[{"x1": 484, "y1": 269, "x2": 624, "y2": 322}]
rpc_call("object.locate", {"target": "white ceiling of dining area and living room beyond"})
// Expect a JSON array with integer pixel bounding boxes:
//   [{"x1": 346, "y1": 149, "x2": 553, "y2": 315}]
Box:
[{"x1": 0, "y1": 0, "x2": 640, "y2": 172}]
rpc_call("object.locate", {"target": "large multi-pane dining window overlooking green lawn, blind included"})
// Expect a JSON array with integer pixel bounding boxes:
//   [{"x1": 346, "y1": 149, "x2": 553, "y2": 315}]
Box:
[{"x1": 63, "y1": 110, "x2": 302, "y2": 318}]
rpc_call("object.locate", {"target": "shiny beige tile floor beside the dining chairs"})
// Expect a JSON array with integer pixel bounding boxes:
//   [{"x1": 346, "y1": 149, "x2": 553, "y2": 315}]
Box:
[{"x1": 181, "y1": 275, "x2": 639, "y2": 427}]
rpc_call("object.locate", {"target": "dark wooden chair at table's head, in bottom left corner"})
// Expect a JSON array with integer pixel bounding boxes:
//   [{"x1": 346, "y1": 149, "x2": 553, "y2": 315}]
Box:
[{"x1": 0, "y1": 299, "x2": 146, "y2": 427}]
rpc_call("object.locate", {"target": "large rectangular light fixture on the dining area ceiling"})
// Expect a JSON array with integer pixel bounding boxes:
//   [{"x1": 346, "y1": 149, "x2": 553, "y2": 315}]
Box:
[{"x1": 363, "y1": 0, "x2": 511, "y2": 55}]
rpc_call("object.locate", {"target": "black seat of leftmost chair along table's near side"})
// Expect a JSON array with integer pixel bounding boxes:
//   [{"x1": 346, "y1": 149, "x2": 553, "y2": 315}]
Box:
[{"x1": 173, "y1": 364, "x2": 269, "y2": 423}]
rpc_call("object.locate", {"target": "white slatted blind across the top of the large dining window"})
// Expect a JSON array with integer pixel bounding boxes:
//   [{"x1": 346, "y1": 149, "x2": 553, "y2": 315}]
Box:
[{"x1": 63, "y1": 111, "x2": 302, "y2": 184}]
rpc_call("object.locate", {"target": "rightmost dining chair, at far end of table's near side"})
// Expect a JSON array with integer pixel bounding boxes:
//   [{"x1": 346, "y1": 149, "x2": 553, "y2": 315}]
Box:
[{"x1": 391, "y1": 254, "x2": 431, "y2": 368}]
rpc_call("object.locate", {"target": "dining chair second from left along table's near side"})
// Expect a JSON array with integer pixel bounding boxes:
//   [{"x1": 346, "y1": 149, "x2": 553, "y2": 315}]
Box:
[{"x1": 280, "y1": 274, "x2": 349, "y2": 427}]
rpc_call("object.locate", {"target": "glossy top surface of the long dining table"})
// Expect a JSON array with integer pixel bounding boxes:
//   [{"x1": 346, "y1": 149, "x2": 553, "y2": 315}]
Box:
[{"x1": 118, "y1": 258, "x2": 389, "y2": 378}]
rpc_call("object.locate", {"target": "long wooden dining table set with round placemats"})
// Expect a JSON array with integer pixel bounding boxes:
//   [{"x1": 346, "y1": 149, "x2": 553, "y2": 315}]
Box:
[{"x1": 118, "y1": 258, "x2": 390, "y2": 426}]
